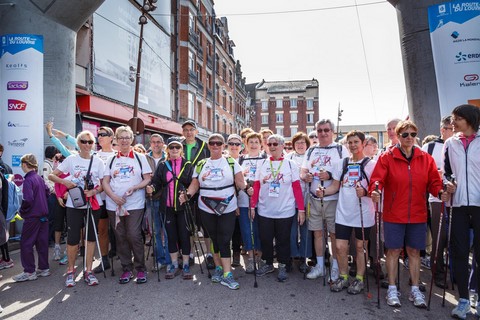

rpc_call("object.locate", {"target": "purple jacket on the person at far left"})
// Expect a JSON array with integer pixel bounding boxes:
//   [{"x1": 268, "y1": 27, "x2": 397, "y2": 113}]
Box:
[{"x1": 19, "y1": 170, "x2": 50, "y2": 219}]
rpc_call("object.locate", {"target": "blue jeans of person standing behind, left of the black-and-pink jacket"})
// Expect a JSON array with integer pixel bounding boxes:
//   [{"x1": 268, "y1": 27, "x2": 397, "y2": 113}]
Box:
[{"x1": 147, "y1": 200, "x2": 172, "y2": 265}]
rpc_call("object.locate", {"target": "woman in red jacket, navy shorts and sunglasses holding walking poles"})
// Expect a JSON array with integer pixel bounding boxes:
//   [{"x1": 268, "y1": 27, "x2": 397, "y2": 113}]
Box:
[{"x1": 369, "y1": 121, "x2": 447, "y2": 308}]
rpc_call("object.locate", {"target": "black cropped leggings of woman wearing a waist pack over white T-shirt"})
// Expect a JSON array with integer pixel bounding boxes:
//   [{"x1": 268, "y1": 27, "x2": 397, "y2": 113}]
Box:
[{"x1": 200, "y1": 210, "x2": 235, "y2": 258}]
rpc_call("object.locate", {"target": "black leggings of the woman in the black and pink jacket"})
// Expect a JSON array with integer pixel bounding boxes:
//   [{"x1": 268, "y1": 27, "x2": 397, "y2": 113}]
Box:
[{"x1": 165, "y1": 208, "x2": 190, "y2": 255}]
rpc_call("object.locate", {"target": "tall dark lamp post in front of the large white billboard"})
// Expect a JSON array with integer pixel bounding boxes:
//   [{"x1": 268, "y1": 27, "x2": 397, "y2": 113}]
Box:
[{"x1": 130, "y1": 0, "x2": 158, "y2": 135}]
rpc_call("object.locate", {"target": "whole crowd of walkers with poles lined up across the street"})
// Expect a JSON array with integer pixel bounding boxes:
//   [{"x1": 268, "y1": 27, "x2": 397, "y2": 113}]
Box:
[{"x1": 0, "y1": 105, "x2": 480, "y2": 319}]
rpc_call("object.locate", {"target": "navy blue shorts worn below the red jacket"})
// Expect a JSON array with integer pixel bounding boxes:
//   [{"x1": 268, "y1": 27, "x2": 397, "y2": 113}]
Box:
[{"x1": 383, "y1": 222, "x2": 427, "y2": 250}]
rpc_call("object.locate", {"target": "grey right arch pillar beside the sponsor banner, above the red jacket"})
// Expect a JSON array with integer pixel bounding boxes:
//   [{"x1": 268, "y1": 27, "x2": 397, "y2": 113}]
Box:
[{"x1": 388, "y1": 0, "x2": 445, "y2": 137}]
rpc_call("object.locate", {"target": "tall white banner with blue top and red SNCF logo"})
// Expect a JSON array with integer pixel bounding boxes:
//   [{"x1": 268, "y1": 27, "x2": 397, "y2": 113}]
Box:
[{"x1": 0, "y1": 34, "x2": 44, "y2": 186}]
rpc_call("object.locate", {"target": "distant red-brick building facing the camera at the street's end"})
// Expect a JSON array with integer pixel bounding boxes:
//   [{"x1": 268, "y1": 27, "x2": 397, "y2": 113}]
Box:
[{"x1": 247, "y1": 79, "x2": 319, "y2": 139}]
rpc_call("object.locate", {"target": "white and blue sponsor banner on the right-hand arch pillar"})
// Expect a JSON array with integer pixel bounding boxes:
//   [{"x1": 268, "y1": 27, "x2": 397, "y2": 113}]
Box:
[{"x1": 428, "y1": 0, "x2": 480, "y2": 117}]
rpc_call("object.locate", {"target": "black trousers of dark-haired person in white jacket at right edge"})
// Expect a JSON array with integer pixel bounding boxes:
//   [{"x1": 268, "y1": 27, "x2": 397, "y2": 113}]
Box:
[{"x1": 450, "y1": 206, "x2": 480, "y2": 300}]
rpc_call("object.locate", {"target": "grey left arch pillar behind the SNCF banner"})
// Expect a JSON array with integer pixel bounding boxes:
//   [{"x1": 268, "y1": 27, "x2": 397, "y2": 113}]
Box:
[{"x1": 0, "y1": 0, "x2": 104, "y2": 141}]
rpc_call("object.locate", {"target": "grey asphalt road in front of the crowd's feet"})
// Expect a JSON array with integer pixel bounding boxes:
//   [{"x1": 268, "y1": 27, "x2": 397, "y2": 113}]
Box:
[{"x1": 0, "y1": 244, "x2": 473, "y2": 320}]
